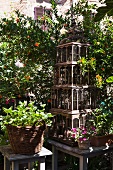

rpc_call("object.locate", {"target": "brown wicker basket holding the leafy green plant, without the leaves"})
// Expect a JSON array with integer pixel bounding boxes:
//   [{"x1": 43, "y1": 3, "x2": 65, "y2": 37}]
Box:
[{"x1": 6, "y1": 124, "x2": 45, "y2": 155}]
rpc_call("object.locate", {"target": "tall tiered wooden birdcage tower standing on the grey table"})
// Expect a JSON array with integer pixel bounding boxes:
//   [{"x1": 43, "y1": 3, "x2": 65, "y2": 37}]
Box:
[{"x1": 50, "y1": 26, "x2": 98, "y2": 145}]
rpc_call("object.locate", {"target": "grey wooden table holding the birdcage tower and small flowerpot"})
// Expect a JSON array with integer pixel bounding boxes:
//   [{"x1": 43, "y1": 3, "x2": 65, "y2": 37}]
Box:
[{"x1": 48, "y1": 140, "x2": 113, "y2": 170}]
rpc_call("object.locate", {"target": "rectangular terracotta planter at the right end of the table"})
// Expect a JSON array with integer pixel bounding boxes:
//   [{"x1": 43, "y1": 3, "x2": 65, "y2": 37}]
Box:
[{"x1": 90, "y1": 134, "x2": 113, "y2": 147}]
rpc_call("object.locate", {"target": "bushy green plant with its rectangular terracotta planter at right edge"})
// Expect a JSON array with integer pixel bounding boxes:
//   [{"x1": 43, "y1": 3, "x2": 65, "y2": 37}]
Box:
[{"x1": 87, "y1": 97, "x2": 113, "y2": 146}]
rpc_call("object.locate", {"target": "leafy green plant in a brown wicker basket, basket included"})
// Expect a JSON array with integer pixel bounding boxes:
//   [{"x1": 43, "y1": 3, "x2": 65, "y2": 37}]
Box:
[{"x1": 0, "y1": 102, "x2": 52, "y2": 154}]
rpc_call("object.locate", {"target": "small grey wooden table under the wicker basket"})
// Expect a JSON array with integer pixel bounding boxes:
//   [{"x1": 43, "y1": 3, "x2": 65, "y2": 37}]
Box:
[{"x1": 0, "y1": 145, "x2": 52, "y2": 170}]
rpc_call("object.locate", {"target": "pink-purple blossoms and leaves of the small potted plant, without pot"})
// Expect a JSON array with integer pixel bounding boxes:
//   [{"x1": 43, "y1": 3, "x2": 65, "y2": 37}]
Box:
[{"x1": 71, "y1": 126, "x2": 96, "y2": 141}]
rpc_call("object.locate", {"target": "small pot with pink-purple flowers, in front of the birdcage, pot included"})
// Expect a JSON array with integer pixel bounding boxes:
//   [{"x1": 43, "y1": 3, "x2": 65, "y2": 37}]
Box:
[{"x1": 71, "y1": 126, "x2": 95, "y2": 149}]
